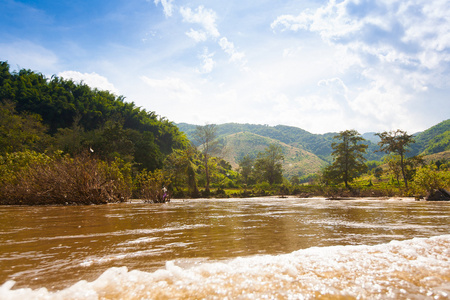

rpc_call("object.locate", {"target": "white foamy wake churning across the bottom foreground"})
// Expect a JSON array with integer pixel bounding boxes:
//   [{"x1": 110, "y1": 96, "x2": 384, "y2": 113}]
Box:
[{"x1": 0, "y1": 235, "x2": 450, "y2": 300}]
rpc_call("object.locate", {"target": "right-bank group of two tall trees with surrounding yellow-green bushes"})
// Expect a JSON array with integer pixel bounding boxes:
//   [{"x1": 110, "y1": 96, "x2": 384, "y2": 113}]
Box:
[{"x1": 321, "y1": 130, "x2": 450, "y2": 200}]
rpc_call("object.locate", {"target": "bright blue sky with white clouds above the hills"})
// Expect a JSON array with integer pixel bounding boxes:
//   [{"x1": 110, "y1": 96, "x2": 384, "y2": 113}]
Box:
[{"x1": 0, "y1": 0, "x2": 450, "y2": 134}]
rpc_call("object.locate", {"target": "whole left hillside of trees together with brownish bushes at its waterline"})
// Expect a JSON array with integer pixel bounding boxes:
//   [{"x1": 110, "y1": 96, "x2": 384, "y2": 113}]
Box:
[{"x1": 0, "y1": 62, "x2": 220, "y2": 204}]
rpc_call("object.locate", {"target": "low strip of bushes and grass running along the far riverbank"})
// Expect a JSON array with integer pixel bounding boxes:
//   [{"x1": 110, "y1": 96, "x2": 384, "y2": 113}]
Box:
[{"x1": 0, "y1": 151, "x2": 448, "y2": 205}]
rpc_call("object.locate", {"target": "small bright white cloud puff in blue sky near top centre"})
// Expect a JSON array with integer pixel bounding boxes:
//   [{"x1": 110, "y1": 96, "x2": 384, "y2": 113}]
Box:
[{"x1": 180, "y1": 5, "x2": 220, "y2": 38}]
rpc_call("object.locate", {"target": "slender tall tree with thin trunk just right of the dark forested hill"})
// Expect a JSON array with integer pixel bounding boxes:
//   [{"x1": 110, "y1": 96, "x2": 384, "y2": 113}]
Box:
[{"x1": 194, "y1": 124, "x2": 219, "y2": 193}]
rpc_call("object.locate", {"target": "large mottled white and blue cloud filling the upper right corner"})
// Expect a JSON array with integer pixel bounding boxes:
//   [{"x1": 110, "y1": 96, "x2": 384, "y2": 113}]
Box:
[{"x1": 271, "y1": 0, "x2": 450, "y2": 91}]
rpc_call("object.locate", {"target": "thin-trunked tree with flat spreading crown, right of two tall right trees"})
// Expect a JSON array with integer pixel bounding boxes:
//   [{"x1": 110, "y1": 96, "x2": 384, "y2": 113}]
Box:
[{"x1": 376, "y1": 129, "x2": 415, "y2": 188}]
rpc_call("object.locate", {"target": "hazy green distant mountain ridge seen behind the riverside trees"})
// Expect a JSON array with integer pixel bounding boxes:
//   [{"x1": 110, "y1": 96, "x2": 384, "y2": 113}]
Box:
[{"x1": 176, "y1": 119, "x2": 450, "y2": 178}]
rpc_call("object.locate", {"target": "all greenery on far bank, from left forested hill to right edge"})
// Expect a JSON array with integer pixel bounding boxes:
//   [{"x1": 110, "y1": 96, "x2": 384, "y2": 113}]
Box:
[{"x1": 0, "y1": 61, "x2": 450, "y2": 205}]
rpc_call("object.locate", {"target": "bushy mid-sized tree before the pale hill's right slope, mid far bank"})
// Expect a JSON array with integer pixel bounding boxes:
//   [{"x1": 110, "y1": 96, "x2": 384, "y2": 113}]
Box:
[{"x1": 255, "y1": 144, "x2": 284, "y2": 184}]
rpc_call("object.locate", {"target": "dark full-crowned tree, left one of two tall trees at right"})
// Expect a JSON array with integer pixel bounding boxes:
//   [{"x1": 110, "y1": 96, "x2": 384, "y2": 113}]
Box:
[{"x1": 324, "y1": 130, "x2": 368, "y2": 188}]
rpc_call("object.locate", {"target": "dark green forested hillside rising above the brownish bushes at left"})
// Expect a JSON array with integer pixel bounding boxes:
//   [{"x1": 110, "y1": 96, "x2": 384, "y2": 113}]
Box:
[{"x1": 0, "y1": 62, "x2": 188, "y2": 170}]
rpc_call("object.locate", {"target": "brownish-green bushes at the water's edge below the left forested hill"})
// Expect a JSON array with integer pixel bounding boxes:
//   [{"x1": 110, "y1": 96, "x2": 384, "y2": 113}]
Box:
[{"x1": 0, "y1": 152, "x2": 131, "y2": 205}]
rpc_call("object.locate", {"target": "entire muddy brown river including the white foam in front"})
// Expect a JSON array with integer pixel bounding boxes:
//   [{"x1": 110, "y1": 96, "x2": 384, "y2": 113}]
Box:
[{"x1": 0, "y1": 198, "x2": 450, "y2": 299}]
